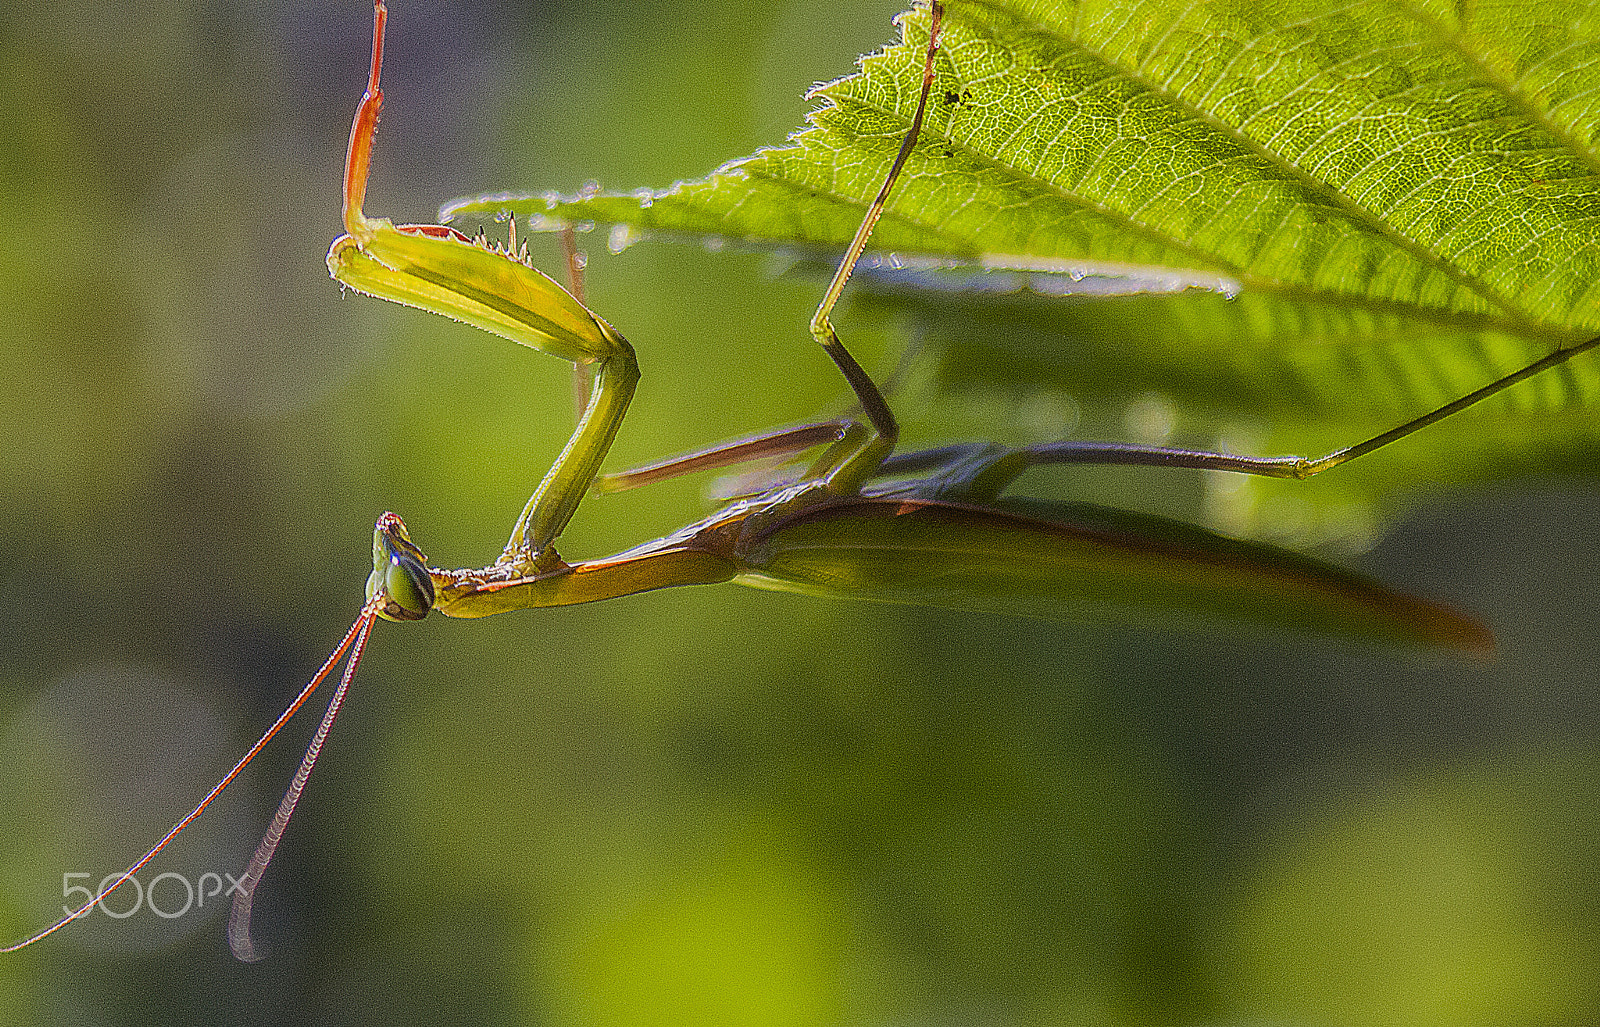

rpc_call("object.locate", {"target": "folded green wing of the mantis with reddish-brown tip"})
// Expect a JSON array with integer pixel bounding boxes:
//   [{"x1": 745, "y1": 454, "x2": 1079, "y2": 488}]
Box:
[{"x1": 734, "y1": 499, "x2": 1494, "y2": 653}]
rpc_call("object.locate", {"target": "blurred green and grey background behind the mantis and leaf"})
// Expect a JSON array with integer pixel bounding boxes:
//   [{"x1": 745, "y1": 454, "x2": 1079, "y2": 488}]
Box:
[{"x1": 0, "y1": 0, "x2": 1600, "y2": 1025}]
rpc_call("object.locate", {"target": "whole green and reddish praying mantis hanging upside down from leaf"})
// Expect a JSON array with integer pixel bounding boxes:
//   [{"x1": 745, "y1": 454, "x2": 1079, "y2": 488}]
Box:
[{"x1": 0, "y1": 0, "x2": 1600, "y2": 960}]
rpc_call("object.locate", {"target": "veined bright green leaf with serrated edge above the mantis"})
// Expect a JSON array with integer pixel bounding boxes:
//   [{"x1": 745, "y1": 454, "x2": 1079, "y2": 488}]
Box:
[{"x1": 451, "y1": 0, "x2": 1600, "y2": 543}]
